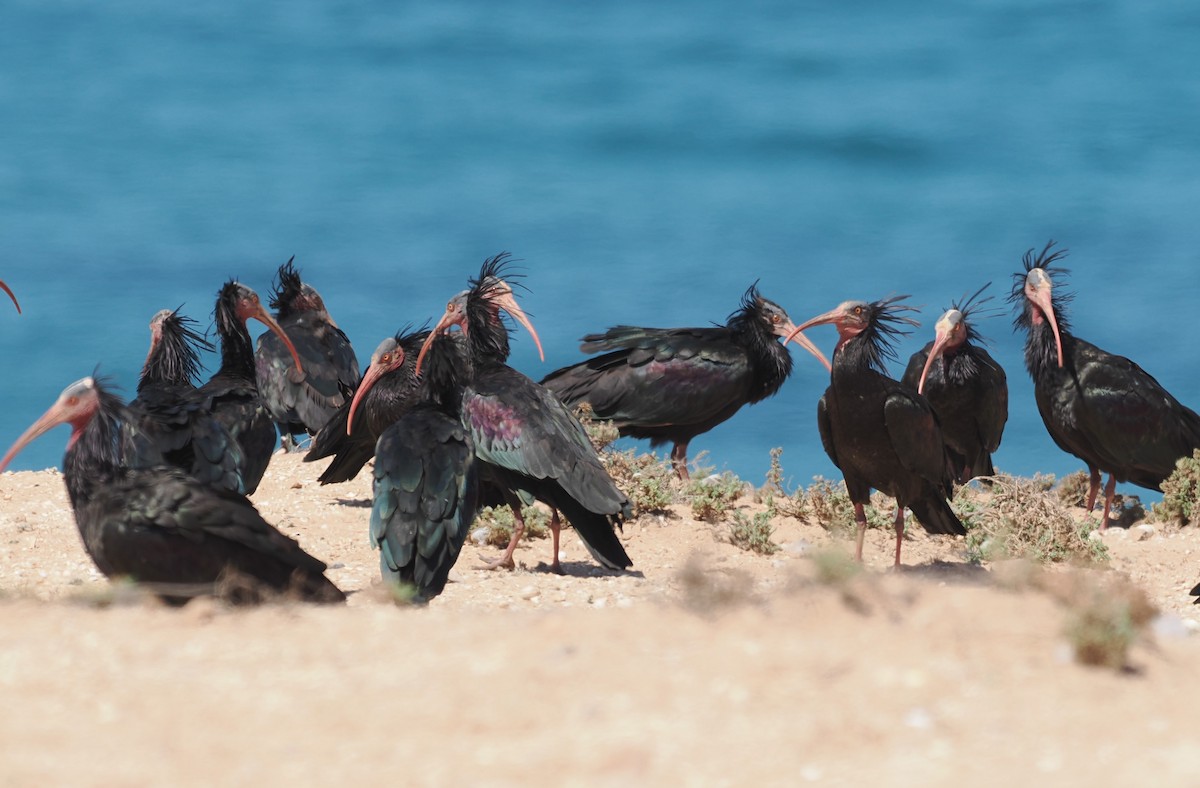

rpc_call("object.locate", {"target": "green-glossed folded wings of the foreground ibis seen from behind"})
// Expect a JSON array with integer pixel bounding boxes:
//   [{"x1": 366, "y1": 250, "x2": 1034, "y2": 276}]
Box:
[{"x1": 371, "y1": 407, "x2": 479, "y2": 600}]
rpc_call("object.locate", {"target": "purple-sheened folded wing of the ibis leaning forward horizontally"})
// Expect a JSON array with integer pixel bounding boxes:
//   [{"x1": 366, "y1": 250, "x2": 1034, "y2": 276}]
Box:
[{"x1": 542, "y1": 326, "x2": 751, "y2": 427}]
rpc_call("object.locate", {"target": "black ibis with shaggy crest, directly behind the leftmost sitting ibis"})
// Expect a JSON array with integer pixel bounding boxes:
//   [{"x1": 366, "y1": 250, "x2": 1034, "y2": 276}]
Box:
[{"x1": 121, "y1": 309, "x2": 244, "y2": 492}]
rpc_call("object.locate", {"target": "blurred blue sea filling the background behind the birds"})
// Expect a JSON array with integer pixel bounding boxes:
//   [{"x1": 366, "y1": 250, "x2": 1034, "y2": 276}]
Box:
[{"x1": 0, "y1": 0, "x2": 1200, "y2": 498}]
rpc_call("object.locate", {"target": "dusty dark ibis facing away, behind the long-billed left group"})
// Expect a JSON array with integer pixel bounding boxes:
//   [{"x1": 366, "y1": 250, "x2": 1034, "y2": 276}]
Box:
[{"x1": 254, "y1": 257, "x2": 359, "y2": 449}]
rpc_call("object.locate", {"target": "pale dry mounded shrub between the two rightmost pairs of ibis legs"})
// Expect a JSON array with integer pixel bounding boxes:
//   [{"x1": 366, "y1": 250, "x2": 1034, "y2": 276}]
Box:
[{"x1": 967, "y1": 474, "x2": 1108, "y2": 564}]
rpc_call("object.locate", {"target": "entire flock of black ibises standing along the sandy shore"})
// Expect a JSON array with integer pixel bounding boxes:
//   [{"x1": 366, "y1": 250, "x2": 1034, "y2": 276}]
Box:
[{"x1": 0, "y1": 242, "x2": 1200, "y2": 603}]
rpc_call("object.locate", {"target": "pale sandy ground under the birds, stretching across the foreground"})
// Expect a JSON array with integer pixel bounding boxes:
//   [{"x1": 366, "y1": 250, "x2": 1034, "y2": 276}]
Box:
[{"x1": 0, "y1": 455, "x2": 1200, "y2": 786}]
